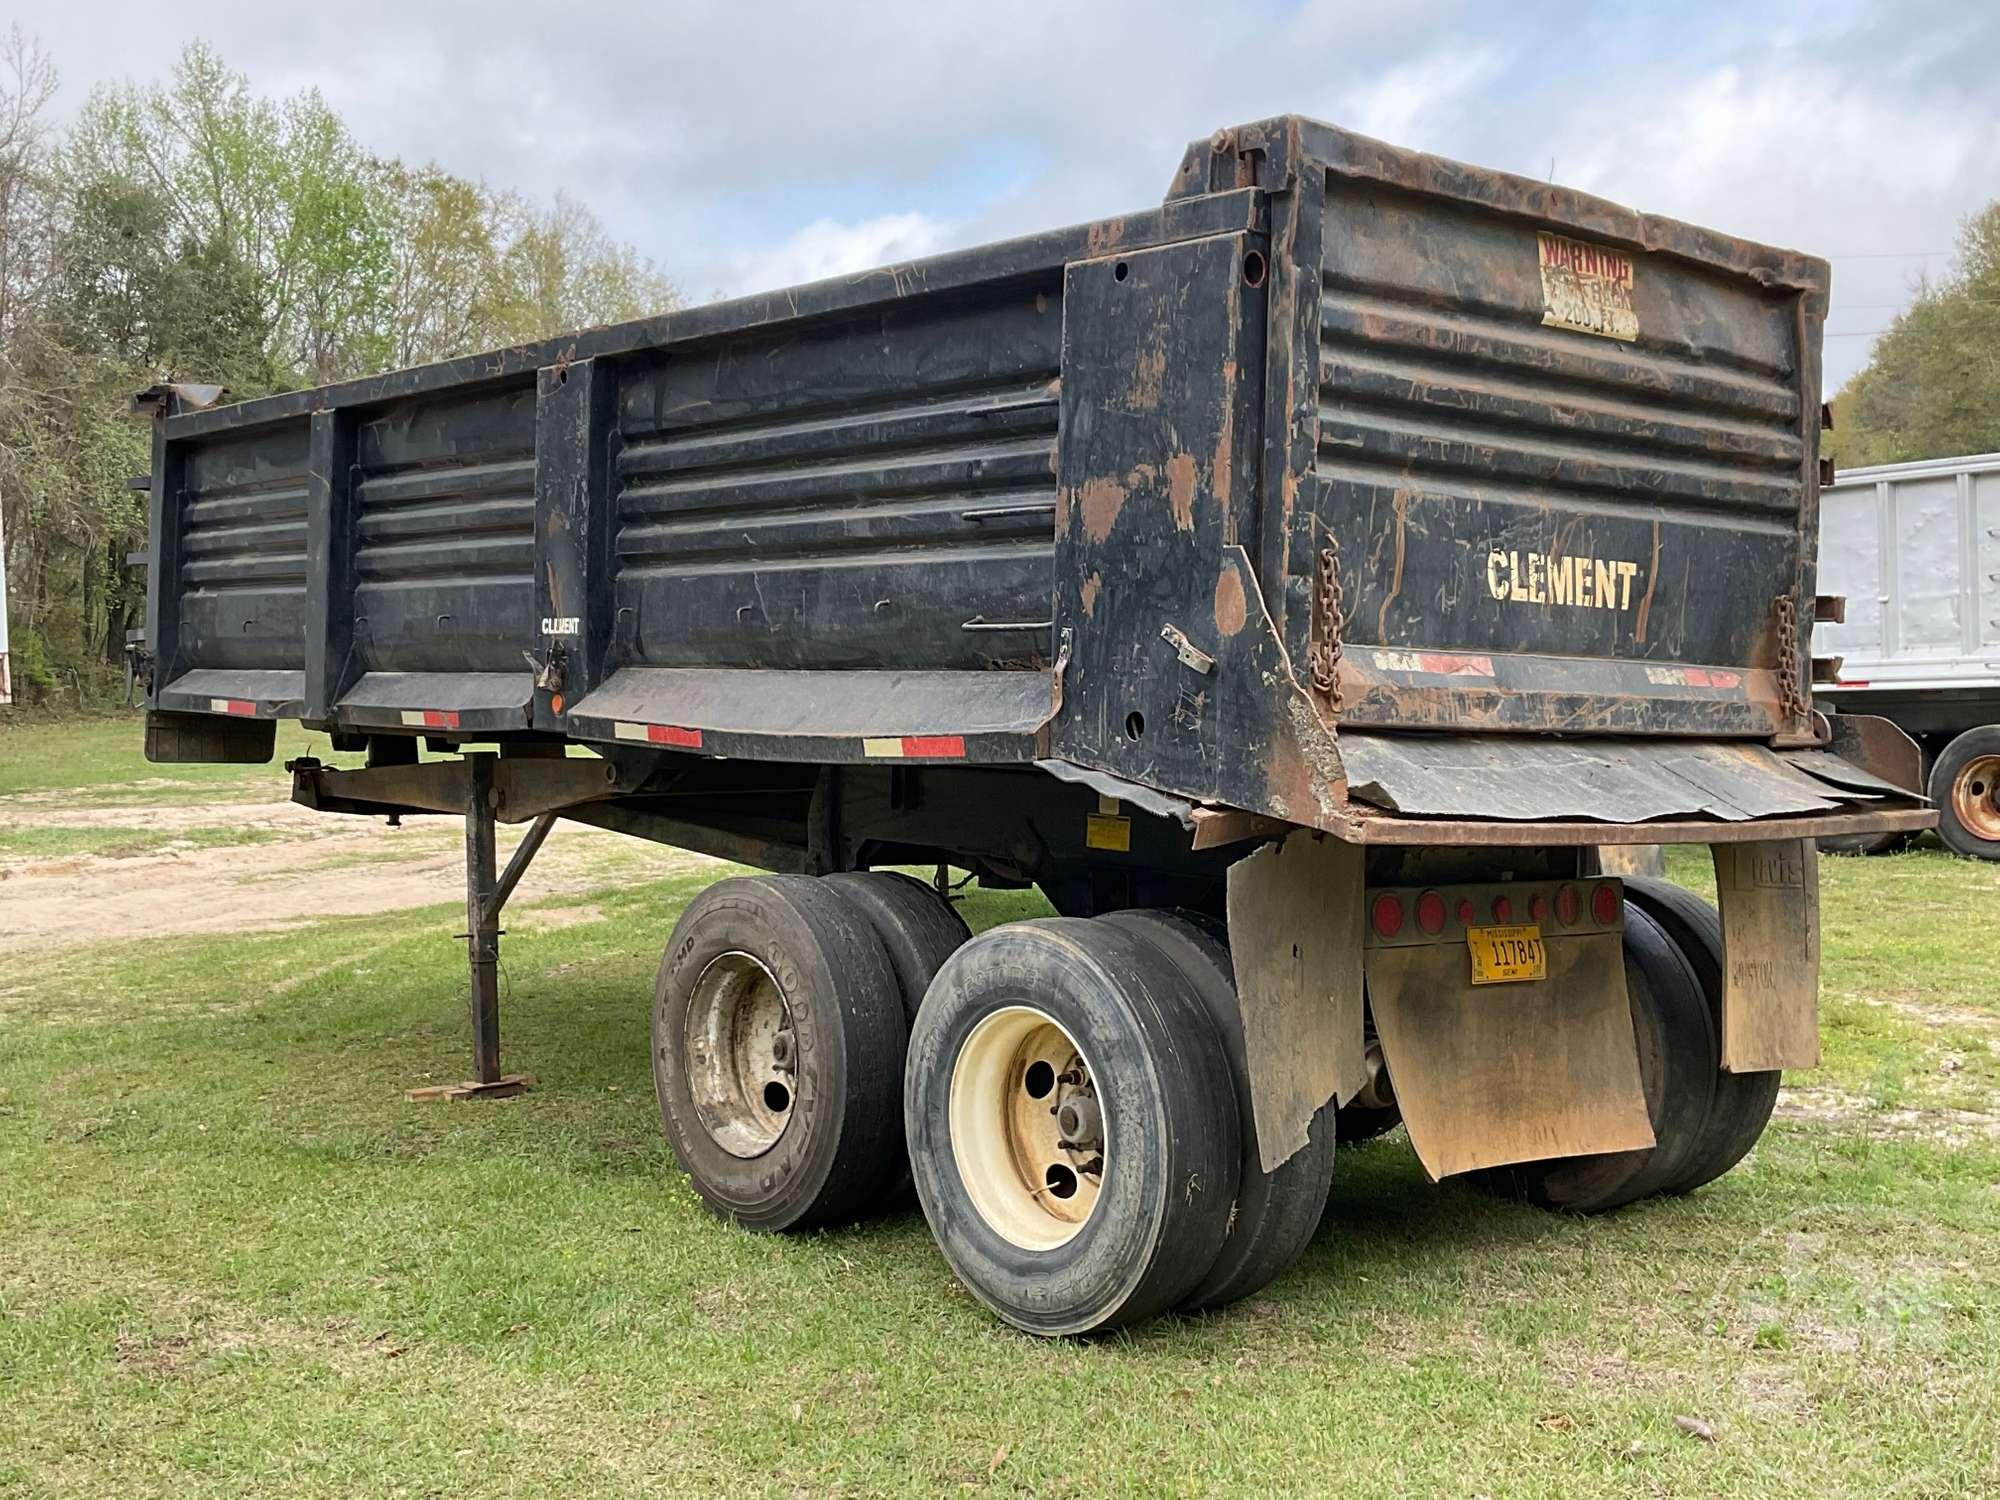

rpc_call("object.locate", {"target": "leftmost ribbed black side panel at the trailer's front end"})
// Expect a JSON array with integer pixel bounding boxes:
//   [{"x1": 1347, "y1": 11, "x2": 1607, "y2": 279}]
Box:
[{"x1": 176, "y1": 422, "x2": 310, "y2": 672}]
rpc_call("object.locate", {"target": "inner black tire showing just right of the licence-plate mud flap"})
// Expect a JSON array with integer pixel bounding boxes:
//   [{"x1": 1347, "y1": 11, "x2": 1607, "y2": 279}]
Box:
[{"x1": 1468, "y1": 902, "x2": 1720, "y2": 1214}]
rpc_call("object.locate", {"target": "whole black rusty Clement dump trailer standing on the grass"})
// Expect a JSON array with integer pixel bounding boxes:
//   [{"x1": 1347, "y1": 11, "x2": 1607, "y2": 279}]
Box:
[{"x1": 142, "y1": 118, "x2": 1932, "y2": 1334}]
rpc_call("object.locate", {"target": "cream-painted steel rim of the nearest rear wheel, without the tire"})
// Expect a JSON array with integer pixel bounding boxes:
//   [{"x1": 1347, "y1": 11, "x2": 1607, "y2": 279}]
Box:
[{"x1": 948, "y1": 1006, "x2": 1110, "y2": 1250}]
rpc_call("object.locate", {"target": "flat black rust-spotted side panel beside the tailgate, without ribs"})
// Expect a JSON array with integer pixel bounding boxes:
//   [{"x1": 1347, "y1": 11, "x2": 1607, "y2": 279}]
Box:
[{"x1": 1050, "y1": 234, "x2": 1346, "y2": 830}]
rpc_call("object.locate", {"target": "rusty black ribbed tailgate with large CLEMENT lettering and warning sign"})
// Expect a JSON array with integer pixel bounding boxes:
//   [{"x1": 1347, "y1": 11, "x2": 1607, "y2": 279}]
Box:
[{"x1": 1172, "y1": 118, "x2": 1826, "y2": 752}]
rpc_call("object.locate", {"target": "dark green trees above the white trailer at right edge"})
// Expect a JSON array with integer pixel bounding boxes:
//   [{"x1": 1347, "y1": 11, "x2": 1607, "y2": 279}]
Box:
[{"x1": 1824, "y1": 202, "x2": 2000, "y2": 468}]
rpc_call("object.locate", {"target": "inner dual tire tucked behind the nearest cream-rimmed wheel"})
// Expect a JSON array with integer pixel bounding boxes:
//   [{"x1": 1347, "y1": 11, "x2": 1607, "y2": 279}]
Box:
[{"x1": 1098, "y1": 910, "x2": 1334, "y2": 1312}]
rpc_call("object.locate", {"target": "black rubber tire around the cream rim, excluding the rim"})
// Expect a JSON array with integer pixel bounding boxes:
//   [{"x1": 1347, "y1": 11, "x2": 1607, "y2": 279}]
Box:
[{"x1": 904, "y1": 918, "x2": 1240, "y2": 1336}]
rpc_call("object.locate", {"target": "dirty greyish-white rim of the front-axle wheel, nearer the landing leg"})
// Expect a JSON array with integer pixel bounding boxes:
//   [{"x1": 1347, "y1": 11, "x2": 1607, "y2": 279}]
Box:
[{"x1": 682, "y1": 952, "x2": 798, "y2": 1160}]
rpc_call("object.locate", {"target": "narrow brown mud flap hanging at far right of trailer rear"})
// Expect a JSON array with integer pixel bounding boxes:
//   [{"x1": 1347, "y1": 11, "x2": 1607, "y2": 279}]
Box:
[{"x1": 1710, "y1": 838, "x2": 1820, "y2": 1072}]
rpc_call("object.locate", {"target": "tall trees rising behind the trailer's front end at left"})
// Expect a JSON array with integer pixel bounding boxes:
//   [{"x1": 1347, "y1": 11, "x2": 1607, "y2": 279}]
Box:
[{"x1": 0, "y1": 26, "x2": 680, "y2": 702}]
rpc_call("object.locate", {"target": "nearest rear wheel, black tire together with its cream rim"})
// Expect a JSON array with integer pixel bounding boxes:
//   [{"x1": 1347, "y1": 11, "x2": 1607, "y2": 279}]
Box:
[{"x1": 904, "y1": 918, "x2": 1240, "y2": 1334}]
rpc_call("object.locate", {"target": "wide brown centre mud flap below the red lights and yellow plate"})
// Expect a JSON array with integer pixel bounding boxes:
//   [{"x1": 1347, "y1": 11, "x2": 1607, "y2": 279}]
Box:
[{"x1": 1366, "y1": 892, "x2": 1654, "y2": 1180}]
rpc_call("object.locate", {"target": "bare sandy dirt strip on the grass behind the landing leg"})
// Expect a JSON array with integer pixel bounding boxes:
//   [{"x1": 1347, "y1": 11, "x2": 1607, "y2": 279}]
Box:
[{"x1": 0, "y1": 796, "x2": 720, "y2": 958}]
